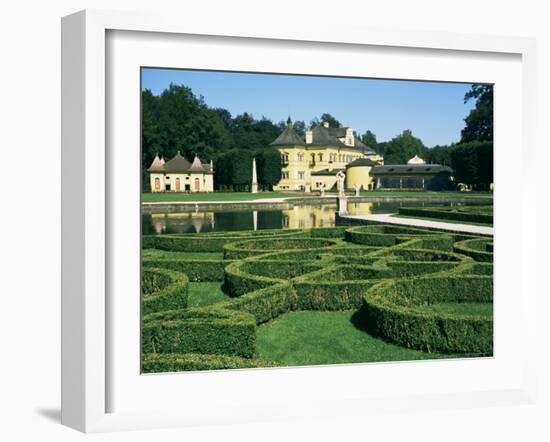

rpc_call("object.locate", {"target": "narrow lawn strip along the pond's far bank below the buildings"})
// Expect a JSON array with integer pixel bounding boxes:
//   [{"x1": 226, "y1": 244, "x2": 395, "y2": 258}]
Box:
[{"x1": 142, "y1": 191, "x2": 493, "y2": 203}]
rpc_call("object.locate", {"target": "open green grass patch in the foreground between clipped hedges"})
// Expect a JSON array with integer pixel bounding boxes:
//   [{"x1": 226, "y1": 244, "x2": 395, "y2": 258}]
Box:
[{"x1": 256, "y1": 311, "x2": 451, "y2": 365}]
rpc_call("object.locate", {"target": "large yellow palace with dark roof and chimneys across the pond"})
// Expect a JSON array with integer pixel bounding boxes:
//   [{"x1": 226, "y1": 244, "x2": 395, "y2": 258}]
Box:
[{"x1": 271, "y1": 117, "x2": 384, "y2": 192}]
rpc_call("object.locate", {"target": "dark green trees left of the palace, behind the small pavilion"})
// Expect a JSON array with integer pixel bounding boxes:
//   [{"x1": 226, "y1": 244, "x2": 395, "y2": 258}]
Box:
[{"x1": 141, "y1": 84, "x2": 305, "y2": 190}]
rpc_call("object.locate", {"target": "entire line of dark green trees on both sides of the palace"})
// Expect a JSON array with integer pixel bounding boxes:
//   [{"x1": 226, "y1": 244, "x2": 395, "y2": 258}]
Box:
[{"x1": 142, "y1": 84, "x2": 493, "y2": 190}]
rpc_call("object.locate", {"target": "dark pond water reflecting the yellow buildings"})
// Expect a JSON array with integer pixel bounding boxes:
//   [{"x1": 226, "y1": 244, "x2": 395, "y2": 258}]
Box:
[{"x1": 142, "y1": 201, "x2": 488, "y2": 234}]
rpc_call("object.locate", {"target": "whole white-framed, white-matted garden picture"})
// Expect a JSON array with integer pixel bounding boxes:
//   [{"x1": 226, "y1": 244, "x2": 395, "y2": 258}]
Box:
[{"x1": 62, "y1": 11, "x2": 536, "y2": 432}]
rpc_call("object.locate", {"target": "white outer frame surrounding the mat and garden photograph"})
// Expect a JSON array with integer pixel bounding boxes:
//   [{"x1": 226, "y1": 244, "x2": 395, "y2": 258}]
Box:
[{"x1": 62, "y1": 10, "x2": 536, "y2": 432}]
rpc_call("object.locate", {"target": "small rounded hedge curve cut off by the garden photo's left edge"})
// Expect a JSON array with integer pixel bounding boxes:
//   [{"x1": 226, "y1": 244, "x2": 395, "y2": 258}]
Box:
[{"x1": 141, "y1": 268, "x2": 189, "y2": 315}]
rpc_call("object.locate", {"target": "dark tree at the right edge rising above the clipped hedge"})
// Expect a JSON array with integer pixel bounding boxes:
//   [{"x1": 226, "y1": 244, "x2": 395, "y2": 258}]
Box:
[{"x1": 460, "y1": 84, "x2": 493, "y2": 143}]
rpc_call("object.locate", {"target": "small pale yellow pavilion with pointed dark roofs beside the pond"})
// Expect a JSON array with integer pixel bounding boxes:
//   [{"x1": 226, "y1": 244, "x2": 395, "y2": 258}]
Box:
[{"x1": 147, "y1": 151, "x2": 214, "y2": 192}]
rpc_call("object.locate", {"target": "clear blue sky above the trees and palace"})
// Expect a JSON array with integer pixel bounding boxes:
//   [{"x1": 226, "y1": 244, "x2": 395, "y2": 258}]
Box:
[{"x1": 142, "y1": 68, "x2": 474, "y2": 147}]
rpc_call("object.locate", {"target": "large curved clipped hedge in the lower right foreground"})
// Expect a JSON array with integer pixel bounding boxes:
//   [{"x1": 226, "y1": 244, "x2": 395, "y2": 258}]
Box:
[{"x1": 364, "y1": 275, "x2": 493, "y2": 354}]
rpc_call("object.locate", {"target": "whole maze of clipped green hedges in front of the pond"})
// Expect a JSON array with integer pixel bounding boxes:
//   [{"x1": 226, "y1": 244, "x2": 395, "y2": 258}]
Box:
[{"x1": 142, "y1": 225, "x2": 493, "y2": 372}]
